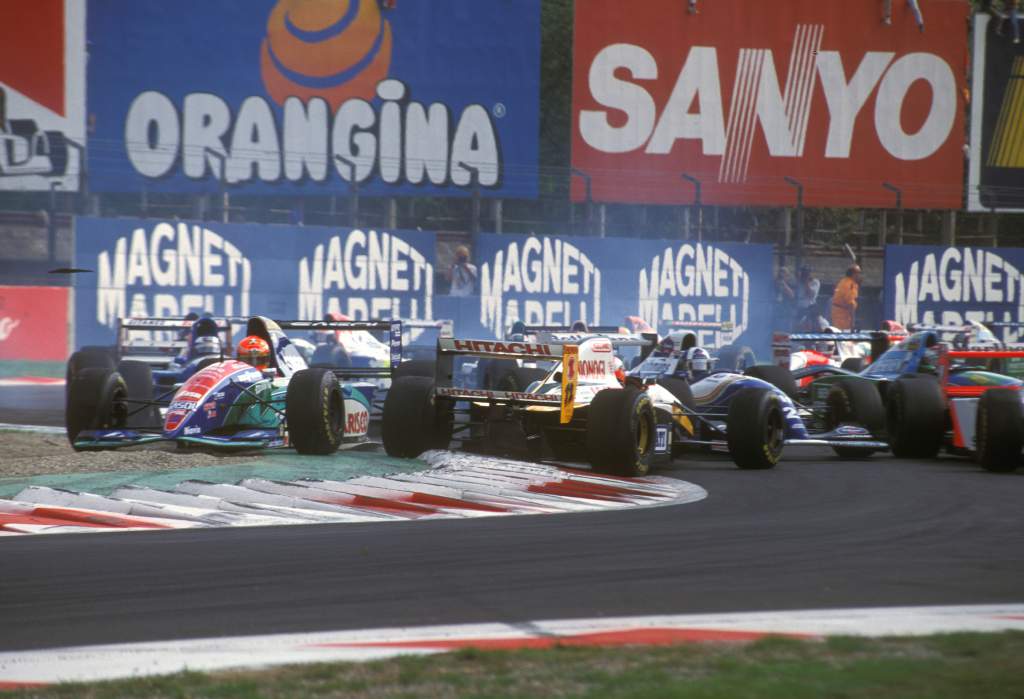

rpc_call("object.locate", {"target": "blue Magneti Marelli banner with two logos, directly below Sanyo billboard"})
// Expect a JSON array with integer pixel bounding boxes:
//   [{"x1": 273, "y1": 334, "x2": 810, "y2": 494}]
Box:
[{"x1": 475, "y1": 234, "x2": 772, "y2": 351}]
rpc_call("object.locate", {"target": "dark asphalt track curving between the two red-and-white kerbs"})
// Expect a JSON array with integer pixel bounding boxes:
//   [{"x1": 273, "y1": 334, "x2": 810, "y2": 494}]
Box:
[{"x1": 6, "y1": 438, "x2": 1024, "y2": 650}]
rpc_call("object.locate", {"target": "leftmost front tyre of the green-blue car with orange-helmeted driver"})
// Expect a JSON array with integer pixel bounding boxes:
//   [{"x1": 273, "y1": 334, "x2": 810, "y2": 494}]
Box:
[{"x1": 65, "y1": 366, "x2": 128, "y2": 449}]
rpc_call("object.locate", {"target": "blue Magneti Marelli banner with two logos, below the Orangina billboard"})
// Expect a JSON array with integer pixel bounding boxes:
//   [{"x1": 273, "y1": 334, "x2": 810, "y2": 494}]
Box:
[{"x1": 75, "y1": 218, "x2": 434, "y2": 346}]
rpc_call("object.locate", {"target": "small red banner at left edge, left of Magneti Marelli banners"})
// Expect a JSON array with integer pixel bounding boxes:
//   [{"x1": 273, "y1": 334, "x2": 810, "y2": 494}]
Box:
[{"x1": 0, "y1": 287, "x2": 69, "y2": 361}]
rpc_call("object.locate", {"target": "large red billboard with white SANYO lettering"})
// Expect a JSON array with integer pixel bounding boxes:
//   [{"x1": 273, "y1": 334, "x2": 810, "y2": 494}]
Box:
[{"x1": 572, "y1": 0, "x2": 969, "y2": 209}]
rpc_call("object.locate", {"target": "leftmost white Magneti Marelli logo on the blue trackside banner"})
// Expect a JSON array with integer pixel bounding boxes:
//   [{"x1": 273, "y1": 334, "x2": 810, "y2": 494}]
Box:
[{"x1": 96, "y1": 222, "x2": 252, "y2": 325}]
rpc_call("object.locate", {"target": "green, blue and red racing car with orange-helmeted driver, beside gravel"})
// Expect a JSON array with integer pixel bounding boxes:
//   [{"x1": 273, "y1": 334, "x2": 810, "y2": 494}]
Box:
[{"x1": 66, "y1": 316, "x2": 401, "y2": 454}]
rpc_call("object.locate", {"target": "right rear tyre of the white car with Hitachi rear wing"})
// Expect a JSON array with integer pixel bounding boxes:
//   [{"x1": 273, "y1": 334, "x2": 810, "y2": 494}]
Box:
[{"x1": 587, "y1": 386, "x2": 657, "y2": 476}]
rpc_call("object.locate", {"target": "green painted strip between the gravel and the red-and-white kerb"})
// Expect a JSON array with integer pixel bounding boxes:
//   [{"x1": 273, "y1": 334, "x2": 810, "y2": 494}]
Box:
[{"x1": 0, "y1": 451, "x2": 430, "y2": 497}]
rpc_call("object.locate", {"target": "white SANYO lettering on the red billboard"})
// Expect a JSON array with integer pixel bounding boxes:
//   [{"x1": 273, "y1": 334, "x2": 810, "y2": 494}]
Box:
[{"x1": 579, "y1": 25, "x2": 958, "y2": 183}]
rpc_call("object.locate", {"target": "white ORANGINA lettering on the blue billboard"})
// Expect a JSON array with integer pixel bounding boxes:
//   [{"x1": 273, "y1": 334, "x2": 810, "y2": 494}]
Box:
[{"x1": 124, "y1": 79, "x2": 502, "y2": 187}]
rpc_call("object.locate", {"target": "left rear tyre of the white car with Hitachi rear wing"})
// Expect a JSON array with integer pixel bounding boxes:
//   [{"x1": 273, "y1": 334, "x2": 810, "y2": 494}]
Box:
[{"x1": 381, "y1": 377, "x2": 455, "y2": 458}]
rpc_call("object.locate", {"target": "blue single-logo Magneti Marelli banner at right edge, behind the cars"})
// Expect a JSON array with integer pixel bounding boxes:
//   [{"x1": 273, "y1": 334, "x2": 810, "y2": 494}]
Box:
[{"x1": 885, "y1": 246, "x2": 1024, "y2": 342}]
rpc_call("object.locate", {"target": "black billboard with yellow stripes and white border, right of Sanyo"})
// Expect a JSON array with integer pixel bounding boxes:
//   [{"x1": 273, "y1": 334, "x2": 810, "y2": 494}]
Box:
[{"x1": 967, "y1": 12, "x2": 1024, "y2": 212}]
